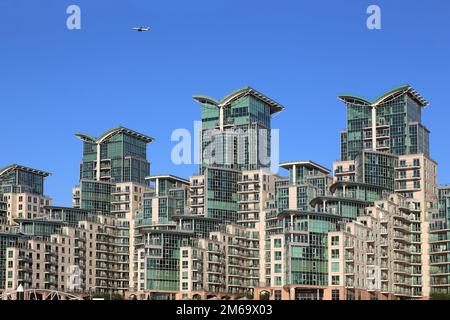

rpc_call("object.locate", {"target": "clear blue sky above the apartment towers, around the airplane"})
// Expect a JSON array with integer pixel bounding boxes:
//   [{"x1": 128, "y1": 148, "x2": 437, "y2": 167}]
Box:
[{"x1": 0, "y1": 0, "x2": 450, "y2": 205}]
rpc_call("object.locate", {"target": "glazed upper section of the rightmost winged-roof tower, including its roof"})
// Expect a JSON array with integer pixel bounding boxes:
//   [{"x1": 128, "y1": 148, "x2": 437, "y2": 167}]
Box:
[{"x1": 339, "y1": 85, "x2": 430, "y2": 161}]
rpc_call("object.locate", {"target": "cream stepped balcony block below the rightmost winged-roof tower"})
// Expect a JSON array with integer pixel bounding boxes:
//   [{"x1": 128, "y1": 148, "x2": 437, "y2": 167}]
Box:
[{"x1": 325, "y1": 195, "x2": 422, "y2": 300}]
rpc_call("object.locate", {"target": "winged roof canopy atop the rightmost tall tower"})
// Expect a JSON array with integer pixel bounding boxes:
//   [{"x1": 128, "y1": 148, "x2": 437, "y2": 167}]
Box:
[{"x1": 339, "y1": 84, "x2": 428, "y2": 108}]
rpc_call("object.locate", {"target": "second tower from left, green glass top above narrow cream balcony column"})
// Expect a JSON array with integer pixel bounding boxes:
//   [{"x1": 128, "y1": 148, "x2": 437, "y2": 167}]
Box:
[{"x1": 73, "y1": 127, "x2": 153, "y2": 293}]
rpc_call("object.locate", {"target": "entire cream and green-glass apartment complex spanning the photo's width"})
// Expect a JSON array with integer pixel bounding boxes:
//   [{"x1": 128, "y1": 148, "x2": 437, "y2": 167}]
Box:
[{"x1": 0, "y1": 86, "x2": 450, "y2": 300}]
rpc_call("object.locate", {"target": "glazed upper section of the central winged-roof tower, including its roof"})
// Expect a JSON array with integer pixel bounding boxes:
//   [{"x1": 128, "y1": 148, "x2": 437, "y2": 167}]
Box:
[{"x1": 193, "y1": 87, "x2": 284, "y2": 174}]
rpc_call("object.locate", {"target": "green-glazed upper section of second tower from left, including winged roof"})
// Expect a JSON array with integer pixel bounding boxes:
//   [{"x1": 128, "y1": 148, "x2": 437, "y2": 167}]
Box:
[{"x1": 74, "y1": 127, "x2": 153, "y2": 213}]
